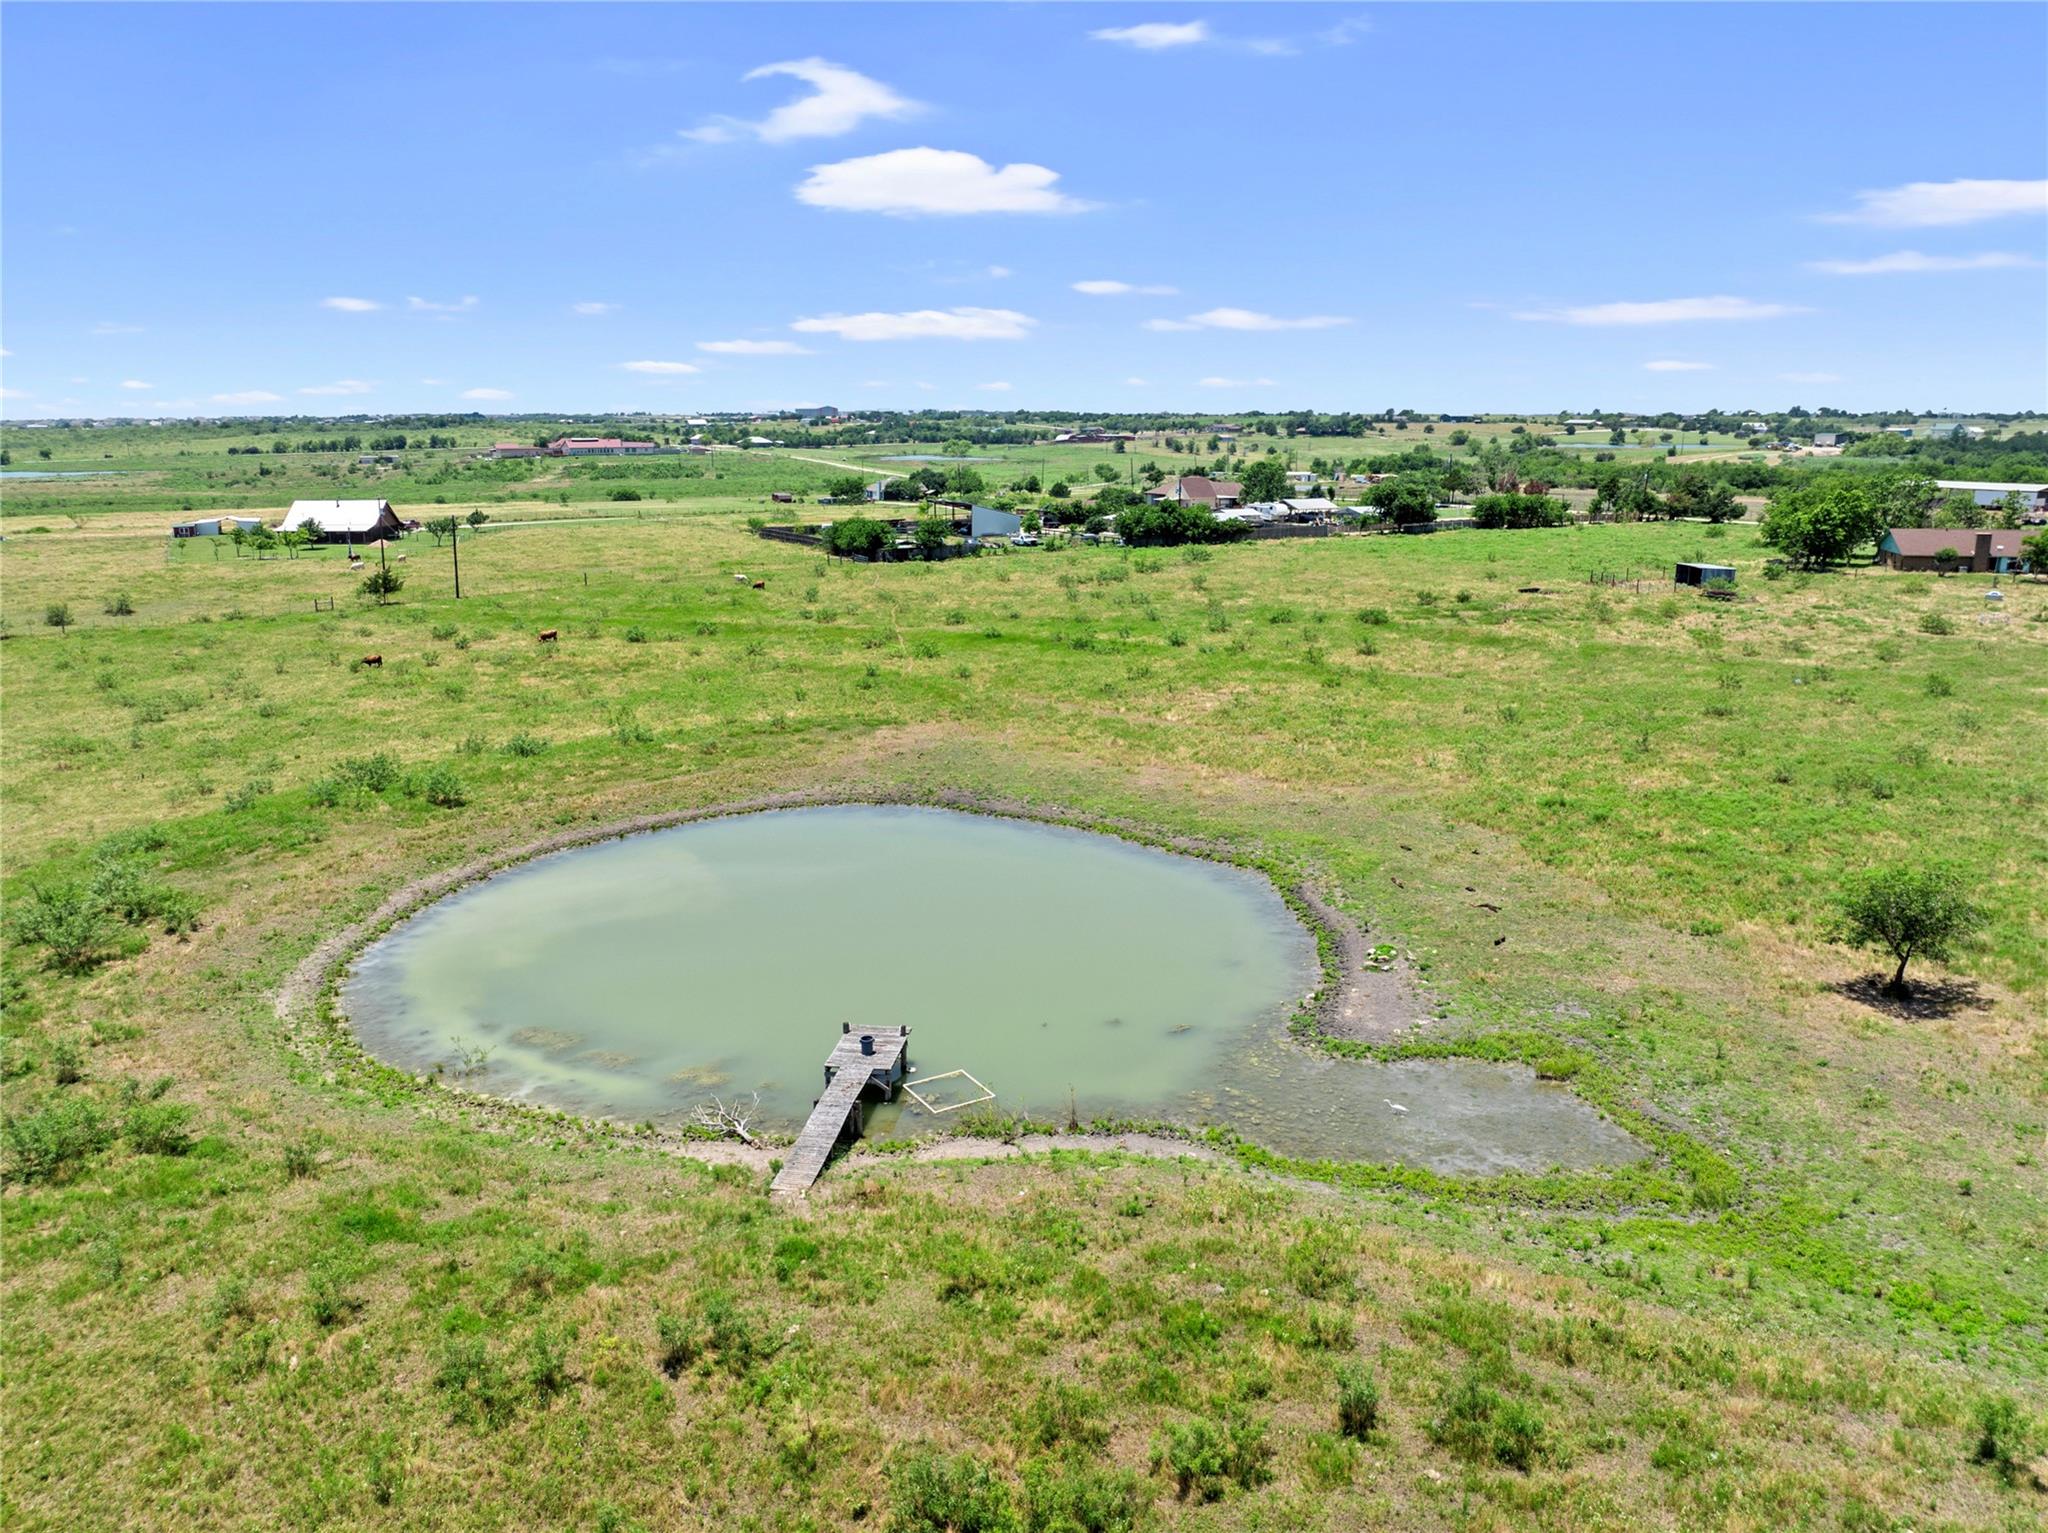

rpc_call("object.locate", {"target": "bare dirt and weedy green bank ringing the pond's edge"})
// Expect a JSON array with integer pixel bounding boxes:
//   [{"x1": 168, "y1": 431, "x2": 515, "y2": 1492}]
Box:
[{"x1": 288, "y1": 790, "x2": 1741, "y2": 1214}]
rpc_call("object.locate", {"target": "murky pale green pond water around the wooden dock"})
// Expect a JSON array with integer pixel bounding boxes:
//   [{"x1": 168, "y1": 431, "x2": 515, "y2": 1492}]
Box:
[{"x1": 342, "y1": 804, "x2": 1640, "y2": 1173}]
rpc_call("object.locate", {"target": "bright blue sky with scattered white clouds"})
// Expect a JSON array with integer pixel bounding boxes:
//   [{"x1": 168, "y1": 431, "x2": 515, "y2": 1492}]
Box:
[{"x1": 0, "y1": 2, "x2": 2048, "y2": 418}]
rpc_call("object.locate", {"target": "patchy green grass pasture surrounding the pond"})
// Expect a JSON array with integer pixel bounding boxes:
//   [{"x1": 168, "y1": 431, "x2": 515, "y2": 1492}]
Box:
[{"x1": 0, "y1": 472, "x2": 2048, "y2": 1531}]
